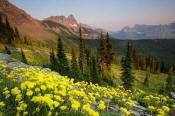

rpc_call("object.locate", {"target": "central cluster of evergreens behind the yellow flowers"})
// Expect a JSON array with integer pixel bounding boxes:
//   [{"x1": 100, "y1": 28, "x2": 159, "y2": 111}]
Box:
[{"x1": 50, "y1": 27, "x2": 114, "y2": 84}]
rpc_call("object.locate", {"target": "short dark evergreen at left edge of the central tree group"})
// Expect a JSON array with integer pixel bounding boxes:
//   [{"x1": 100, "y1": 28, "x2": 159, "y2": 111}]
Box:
[{"x1": 50, "y1": 49, "x2": 58, "y2": 71}]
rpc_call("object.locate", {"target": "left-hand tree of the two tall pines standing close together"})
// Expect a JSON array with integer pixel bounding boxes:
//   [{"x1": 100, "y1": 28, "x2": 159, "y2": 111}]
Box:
[{"x1": 98, "y1": 32, "x2": 106, "y2": 78}]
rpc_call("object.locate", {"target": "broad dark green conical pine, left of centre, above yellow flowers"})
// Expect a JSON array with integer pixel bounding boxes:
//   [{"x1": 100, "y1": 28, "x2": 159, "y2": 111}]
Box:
[{"x1": 57, "y1": 38, "x2": 70, "y2": 76}]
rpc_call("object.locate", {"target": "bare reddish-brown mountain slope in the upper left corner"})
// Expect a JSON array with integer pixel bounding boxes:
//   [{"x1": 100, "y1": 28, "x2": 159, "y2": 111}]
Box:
[{"x1": 0, "y1": 0, "x2": 53, "y2": 39}]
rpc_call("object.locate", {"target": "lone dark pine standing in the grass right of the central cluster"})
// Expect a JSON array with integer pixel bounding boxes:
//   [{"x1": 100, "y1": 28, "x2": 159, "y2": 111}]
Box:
[{"x1": 121, "y1": 42, "x2": 135, "y2": 89}]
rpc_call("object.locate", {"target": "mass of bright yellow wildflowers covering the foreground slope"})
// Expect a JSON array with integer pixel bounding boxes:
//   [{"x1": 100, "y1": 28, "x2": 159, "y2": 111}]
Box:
[{"x1": 0, "y1": 61, "x2": 174, "y2": 116}]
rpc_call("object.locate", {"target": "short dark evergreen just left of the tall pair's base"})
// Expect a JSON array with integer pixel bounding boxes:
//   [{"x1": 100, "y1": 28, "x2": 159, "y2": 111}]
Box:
[{"x1": 91, "y1": 56, "x2": 101, "y2": 84}]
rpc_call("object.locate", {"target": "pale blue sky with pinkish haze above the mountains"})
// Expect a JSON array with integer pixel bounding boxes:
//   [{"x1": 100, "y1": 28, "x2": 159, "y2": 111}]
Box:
[{"x1": 9, "y1": 0, "x2": 175, "y2": 31}]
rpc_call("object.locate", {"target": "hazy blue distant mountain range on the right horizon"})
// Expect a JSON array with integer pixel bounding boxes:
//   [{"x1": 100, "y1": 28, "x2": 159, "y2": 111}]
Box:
[{"x1": 112, "y1": 22, "x2": 175, "y2": 40}]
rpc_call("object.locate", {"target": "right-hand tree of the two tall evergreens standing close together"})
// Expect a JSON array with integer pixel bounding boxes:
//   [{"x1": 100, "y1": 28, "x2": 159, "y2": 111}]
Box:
[{"x1": 105, "y1": 33, "x2": 114, "y2": 69}]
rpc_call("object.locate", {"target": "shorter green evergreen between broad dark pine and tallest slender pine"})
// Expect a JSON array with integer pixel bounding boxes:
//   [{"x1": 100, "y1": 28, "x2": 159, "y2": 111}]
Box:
[{"x1": 71, "y1": 48, "x2": 81, "y2": 81}]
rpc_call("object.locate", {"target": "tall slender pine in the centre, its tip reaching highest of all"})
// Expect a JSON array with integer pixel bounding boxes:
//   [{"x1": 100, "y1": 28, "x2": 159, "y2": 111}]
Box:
[{"x1": 79, "y1": 26, "x2": 86, "y2": 73}]
